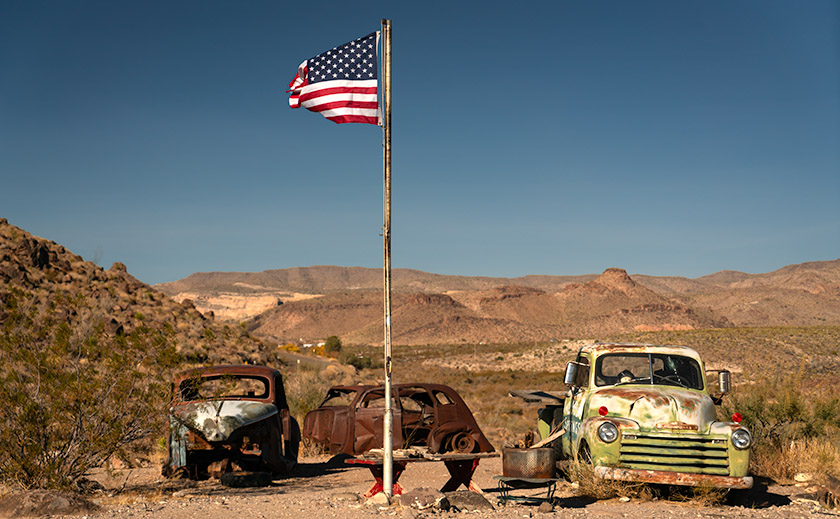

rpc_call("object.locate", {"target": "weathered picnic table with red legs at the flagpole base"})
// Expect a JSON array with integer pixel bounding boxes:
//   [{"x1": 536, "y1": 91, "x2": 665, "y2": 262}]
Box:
[{"x1": 344, "y1": 449, "x2": 499, "y2": 497}]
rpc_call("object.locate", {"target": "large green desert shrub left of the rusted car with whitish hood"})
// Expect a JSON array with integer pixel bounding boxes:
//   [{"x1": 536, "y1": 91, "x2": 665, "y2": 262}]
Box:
[{"x1": 0, "y1": 290, "x2": 178, "y2": 489}]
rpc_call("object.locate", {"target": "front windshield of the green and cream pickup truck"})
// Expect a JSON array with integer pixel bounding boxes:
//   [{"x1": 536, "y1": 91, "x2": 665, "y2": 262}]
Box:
[{"x1": 595, "y1": 353, "x2": 703, "y2": 389}]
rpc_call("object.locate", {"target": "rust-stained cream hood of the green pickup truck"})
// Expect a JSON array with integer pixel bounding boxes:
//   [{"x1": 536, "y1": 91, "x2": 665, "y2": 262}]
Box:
[{"x1": 589, "y1": 385, "x2": 715, "y2": 434}]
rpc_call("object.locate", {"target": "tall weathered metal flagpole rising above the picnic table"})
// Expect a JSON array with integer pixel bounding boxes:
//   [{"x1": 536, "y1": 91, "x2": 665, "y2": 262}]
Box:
[{"x1": 382, "y1": 18, "x2": 394, "y2": 497}]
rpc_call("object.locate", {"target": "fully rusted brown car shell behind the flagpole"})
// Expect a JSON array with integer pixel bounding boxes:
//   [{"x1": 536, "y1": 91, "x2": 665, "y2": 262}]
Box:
[{"x1": 303, "y1": 384, "x2": 493, "y2": 455}]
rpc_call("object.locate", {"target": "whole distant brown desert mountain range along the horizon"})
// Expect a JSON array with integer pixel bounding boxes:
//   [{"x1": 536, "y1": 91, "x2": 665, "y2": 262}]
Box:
[{"x1": 156, "y1": 260, "x2": 840, "y2": 345}]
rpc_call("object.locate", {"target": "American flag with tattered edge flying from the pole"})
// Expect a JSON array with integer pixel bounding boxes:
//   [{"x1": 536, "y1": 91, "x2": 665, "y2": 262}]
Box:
[{"x1": 288, "y1": 32, "x2": 379, "y2": 124}]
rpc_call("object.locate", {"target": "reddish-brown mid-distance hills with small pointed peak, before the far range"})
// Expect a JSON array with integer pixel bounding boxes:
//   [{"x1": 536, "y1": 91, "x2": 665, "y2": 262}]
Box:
[{"x1": 249, "y1": 269, "x2": 730, "y2": 345}]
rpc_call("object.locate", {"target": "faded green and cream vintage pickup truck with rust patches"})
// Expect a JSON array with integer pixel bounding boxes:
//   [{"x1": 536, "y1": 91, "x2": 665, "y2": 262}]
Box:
[{"x1": 518, "y1": 344, "x2": 753, "y2": 488}]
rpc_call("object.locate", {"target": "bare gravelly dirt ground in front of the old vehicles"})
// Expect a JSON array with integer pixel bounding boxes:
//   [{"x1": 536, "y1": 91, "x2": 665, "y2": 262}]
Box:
[{"x1": 0, "y1": 457, "x2": 840, "y2": 519}]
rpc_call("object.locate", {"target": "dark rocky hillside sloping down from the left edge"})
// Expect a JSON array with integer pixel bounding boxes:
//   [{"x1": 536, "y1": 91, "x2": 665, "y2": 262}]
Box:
[{"x1": 0, "y1": 218, "x2": 277, "y2": 364}]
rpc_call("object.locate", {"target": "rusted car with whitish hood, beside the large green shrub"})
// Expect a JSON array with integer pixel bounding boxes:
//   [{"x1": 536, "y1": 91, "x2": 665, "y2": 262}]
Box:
[{"x1": 163, "y1": 366, "x2": 300, "y2": 478}]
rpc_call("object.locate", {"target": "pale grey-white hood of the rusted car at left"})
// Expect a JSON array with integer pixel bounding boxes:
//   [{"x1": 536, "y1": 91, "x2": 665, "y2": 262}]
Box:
[{"x1": 171, "y1": 400, "x2": 277, "y2": 442}]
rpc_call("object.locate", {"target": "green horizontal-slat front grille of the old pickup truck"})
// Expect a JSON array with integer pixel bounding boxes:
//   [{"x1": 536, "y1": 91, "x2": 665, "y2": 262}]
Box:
[{"x1": 618, "y1": 433, "x2": 729, "y2": 476}]
